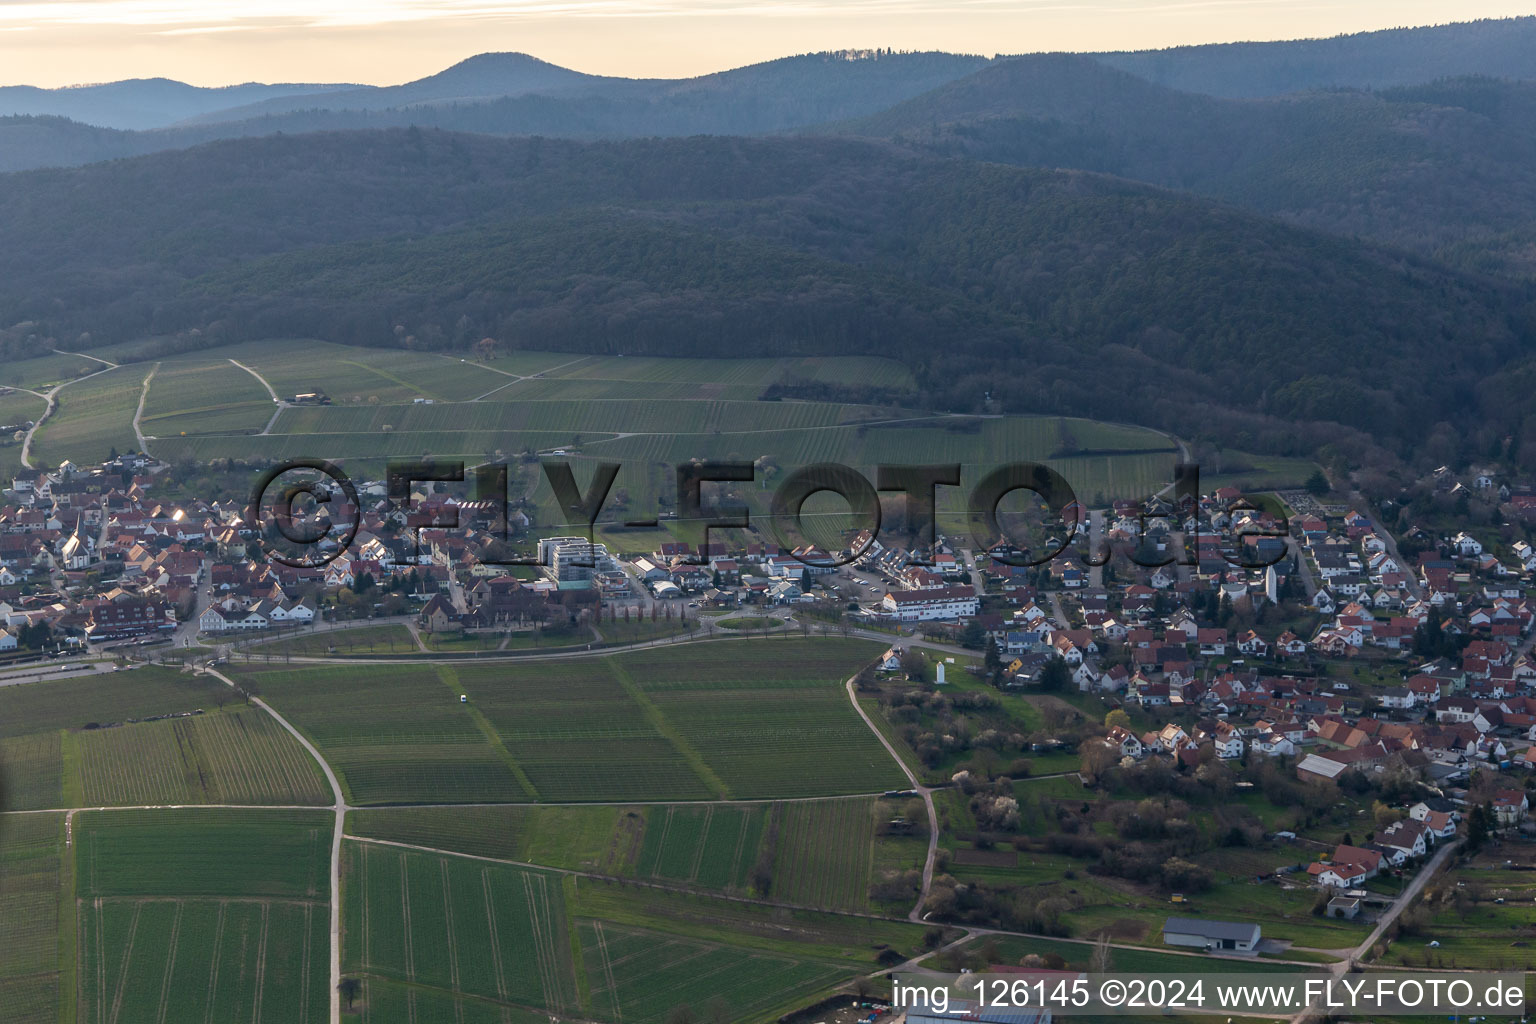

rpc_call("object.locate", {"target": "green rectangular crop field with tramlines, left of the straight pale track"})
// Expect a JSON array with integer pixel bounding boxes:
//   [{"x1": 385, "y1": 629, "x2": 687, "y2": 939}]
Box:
[{"x1": 74, "y1": 809, "x2": 333, "y2": 1024}]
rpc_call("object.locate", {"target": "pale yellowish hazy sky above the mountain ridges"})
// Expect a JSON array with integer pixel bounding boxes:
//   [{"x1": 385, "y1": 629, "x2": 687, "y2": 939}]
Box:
[{"x1": 0, "y1": 0, "x2": 1536, "y2": 86}]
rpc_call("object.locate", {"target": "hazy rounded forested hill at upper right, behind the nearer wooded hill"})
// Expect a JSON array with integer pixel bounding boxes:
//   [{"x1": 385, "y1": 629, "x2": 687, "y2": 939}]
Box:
[{"x1": 828, "y1": 55, "x2": 1536, "y2": 276}]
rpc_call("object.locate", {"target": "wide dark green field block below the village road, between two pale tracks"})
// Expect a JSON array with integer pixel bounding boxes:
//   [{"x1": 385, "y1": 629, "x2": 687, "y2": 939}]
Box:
[{"x1": 235, "y1": 639, "x2": 903, "y2": 804}]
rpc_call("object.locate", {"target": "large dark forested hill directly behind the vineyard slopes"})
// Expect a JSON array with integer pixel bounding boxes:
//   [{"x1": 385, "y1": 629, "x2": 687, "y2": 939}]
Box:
[{"x1": 0, "y1": 129, "x2": 1536, "y2": 463}]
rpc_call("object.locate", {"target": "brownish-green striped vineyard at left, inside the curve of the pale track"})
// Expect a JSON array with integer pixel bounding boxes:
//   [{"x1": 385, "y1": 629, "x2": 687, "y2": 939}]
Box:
[{"x1": 80, "y1": 711, "x2": 330, "y2": 806}]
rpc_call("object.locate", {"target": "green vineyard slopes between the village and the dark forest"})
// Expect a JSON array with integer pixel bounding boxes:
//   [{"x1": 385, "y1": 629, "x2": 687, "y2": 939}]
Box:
[{"x1": 0, "y1": 339, "x2": 1185, "y2": 508}]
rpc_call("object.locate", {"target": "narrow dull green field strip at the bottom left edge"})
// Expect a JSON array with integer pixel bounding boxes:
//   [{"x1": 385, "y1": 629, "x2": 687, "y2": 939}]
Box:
[{"x1": 0, "y1": 814, "x2": 69, "y2": 1024}]
